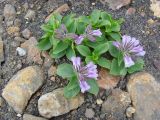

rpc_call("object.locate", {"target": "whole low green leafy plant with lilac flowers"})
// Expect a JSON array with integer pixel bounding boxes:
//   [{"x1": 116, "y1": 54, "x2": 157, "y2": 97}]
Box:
[{"x1": 38, "y1": 10, "x2": 145, "y2": 98}]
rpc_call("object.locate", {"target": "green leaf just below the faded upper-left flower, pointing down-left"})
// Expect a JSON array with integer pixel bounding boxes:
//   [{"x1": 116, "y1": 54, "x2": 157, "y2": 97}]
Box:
[{"x1": 53, "y1": 41, "x2": 68, "y2": 54}]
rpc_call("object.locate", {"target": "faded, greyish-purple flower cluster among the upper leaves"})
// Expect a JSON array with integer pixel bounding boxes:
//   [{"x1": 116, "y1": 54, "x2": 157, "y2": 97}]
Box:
[{"x1": 55, "y1": 24, "x2": 102, "y2": 45}]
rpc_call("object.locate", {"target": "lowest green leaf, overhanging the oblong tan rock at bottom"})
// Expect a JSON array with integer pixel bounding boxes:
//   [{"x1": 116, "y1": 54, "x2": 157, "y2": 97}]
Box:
[{"x1": 64, "y1": 77, "x2": 80, "y2": 98}]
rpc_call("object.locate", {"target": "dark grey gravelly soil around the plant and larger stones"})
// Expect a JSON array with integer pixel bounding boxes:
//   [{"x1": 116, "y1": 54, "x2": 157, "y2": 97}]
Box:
[{"x1": 0, "y1": 0, "x2": 160, "y2": 120}]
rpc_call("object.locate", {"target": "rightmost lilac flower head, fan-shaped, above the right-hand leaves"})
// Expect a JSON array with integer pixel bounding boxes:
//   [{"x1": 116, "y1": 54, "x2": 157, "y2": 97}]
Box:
[{"x1": 113, "y1": 35, "x2": 145, "y2": 67}]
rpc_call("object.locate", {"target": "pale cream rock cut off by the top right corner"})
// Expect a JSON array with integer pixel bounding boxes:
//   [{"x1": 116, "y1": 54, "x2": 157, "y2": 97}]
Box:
[{"x1": 150, "y1": 0, "x2": 160, "y2": 17}]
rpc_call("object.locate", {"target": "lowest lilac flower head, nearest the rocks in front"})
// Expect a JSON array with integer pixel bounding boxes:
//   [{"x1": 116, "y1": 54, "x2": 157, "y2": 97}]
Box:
[{"x1": 71, "y1": 57, "x2": 98, "y2": 93}]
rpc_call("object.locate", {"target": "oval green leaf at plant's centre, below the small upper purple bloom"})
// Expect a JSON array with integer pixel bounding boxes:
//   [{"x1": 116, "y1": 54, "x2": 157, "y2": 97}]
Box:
[{"x1": 77, "y1": 45, "x2": 91, "y2": 56}]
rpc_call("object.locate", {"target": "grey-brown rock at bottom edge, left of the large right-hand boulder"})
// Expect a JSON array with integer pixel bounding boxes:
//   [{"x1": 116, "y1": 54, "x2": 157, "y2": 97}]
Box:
[{"x1": 102, "y1": 88, "x2": 131, "y2": 120}]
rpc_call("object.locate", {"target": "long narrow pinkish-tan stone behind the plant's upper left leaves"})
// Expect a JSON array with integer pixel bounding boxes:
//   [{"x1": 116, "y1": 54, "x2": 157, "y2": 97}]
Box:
[{"x1": 45, "y1": 4, "x2": 70, "y2": 22}]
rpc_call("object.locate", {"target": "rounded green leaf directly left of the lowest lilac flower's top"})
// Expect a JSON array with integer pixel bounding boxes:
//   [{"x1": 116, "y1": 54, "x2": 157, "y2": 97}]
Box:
[{"x1": 57, "y1": 63, "x2": 75, "y2": 78}]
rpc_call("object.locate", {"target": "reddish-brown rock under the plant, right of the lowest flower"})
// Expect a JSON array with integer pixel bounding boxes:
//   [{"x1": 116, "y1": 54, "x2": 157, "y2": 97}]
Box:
[{"x1": 97, "y1": 68, "x2": 120, "y2": 89}]
